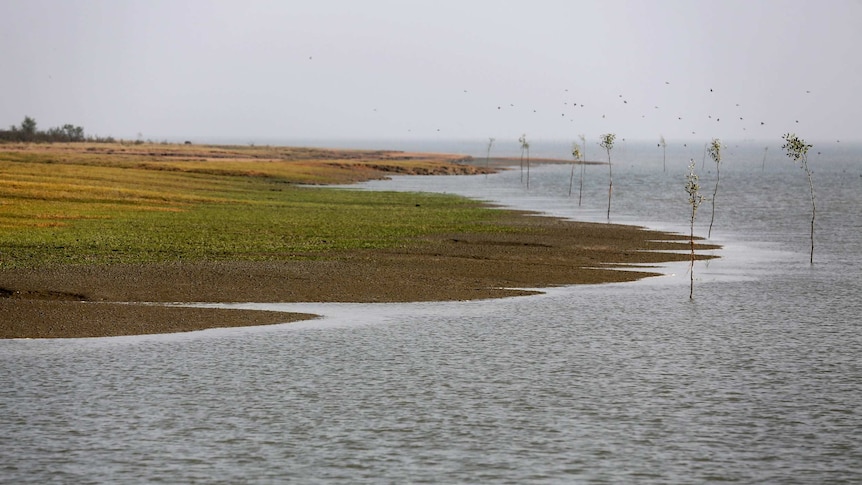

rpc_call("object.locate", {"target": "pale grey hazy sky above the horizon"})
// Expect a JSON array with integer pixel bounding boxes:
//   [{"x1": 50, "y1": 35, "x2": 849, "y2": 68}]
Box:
[{"x1": 0, "y1": 0, "x2": 862, "y2": 142}]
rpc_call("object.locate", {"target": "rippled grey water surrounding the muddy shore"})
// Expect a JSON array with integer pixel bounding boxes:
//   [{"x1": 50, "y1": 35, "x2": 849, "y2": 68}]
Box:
[{"x1": 0, "y1": 139, "x2": 862, "y2": 483}]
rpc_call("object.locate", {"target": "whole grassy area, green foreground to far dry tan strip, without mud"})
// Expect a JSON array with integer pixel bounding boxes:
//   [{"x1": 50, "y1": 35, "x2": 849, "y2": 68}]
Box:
[{"x1": 0, "y1": 143, "x2": 509, "y2": 268}]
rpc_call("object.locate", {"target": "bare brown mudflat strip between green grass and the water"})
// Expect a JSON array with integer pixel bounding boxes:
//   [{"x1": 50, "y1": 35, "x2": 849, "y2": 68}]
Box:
[{"x1": 0, "y1": 211, "x2": 714, "y2": 339}]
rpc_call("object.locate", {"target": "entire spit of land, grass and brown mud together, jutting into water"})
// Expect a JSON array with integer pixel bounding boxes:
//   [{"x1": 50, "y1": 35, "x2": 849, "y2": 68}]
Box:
[{"x1": 0, "y1": 143, "x2": 714, "y2": 338}]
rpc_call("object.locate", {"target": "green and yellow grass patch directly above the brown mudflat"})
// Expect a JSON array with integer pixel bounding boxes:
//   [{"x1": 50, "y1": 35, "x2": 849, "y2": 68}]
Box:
[{"x1": 0, "y1": 148, "x2": 506, "y2": 268}]
